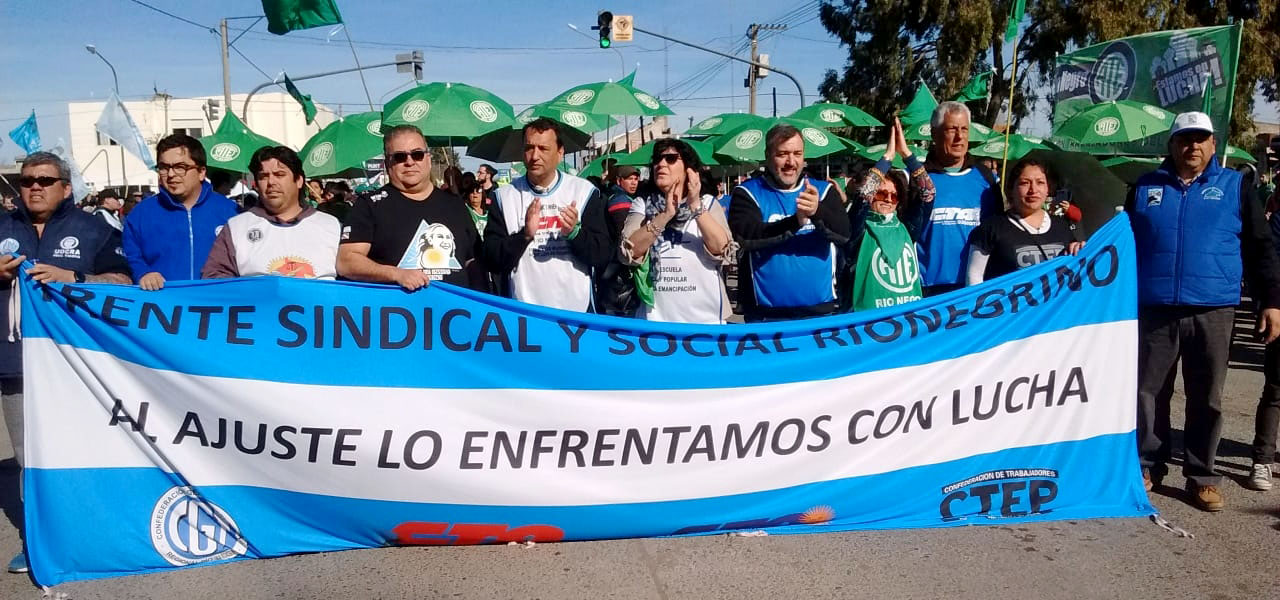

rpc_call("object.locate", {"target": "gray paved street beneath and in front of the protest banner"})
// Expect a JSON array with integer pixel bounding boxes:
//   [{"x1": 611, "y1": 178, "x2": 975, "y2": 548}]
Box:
[{"x1": 0, "y1": 305, "x2": 1280, "y2": 600}]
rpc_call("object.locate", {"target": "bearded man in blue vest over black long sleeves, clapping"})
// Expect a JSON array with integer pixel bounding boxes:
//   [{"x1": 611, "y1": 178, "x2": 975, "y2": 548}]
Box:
[{"x1": 728, "y1": 124, "x2": 850, "y2": 322}]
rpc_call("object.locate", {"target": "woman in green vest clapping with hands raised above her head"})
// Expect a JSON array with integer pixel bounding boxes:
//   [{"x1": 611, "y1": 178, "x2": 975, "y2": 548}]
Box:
[{"x1": 841, "y1": 119, "x2": 933, "y2": 311}]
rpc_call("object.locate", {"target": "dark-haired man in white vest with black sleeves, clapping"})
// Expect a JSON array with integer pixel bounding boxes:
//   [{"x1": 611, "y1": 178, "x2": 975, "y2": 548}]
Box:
[{"x1": 484, "y1": 118, "x2": 617, "y2": 312}]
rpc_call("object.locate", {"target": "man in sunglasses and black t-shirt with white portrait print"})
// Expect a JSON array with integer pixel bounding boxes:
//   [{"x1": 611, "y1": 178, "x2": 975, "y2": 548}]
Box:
[{"x1": 338, "y1": 125, "x2": 485, "y2": 290}]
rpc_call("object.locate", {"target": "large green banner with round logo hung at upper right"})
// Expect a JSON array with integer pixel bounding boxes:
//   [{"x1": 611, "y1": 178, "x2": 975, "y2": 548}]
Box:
[{"x1": 1052, "y1": 24, "x2": 1240, "y2": 155}]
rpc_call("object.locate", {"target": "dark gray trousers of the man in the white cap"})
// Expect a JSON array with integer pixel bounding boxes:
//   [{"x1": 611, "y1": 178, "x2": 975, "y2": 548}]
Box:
[{"x1": 1138, "y1": 306, "x2": 1235, "y2": 485}]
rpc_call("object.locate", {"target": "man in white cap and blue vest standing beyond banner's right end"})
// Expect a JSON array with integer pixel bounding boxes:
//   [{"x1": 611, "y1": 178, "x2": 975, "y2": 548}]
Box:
[{"x1": 1125, "y1": 113, "x2": 1280, "y2": 512}]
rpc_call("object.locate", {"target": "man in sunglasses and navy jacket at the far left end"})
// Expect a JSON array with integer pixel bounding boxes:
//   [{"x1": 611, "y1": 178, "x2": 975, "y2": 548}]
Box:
[{"x1": 0, "y1": 152, "x2": 131, "y2": 573}]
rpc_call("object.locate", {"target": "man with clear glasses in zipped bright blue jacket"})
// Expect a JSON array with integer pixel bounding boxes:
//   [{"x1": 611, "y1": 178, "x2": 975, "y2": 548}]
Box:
[{"x1": 124, "y1": 133, "x2": 238, "y2": 290}]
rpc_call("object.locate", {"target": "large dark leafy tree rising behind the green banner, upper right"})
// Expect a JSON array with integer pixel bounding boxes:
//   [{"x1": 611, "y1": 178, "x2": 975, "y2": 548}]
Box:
[{"x1": 819, "y1": 0, "x2": 1280, "y2": 143}]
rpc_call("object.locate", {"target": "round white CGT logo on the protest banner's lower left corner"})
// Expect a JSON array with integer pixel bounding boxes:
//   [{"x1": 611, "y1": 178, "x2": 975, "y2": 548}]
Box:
[{"x1": 150, "y1": 486, "x2": 248, "y2": 567}]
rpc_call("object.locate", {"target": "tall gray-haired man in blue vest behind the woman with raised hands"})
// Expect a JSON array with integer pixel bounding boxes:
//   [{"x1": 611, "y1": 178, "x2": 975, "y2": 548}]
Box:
[{"x1": 902, "y1": 101, "x2": 1005, "y2": 297}]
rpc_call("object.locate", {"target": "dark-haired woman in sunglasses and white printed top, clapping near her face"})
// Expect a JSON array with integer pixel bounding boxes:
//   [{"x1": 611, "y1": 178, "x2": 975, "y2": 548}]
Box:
[{"x1": 622, "y1": 139, "x2": 737, "y2": 324}]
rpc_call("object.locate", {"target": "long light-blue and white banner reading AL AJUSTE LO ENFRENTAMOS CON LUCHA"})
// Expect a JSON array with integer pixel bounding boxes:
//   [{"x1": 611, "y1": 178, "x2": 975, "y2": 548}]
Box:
[{"x1": 22, "y1": 215, "x2": 1152, "y2": 585}]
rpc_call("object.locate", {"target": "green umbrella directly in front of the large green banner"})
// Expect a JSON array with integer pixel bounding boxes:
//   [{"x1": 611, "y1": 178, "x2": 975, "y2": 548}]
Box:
[{"x1": 1053, "y1": 100, "x2": 1174, "y2": 146}]
